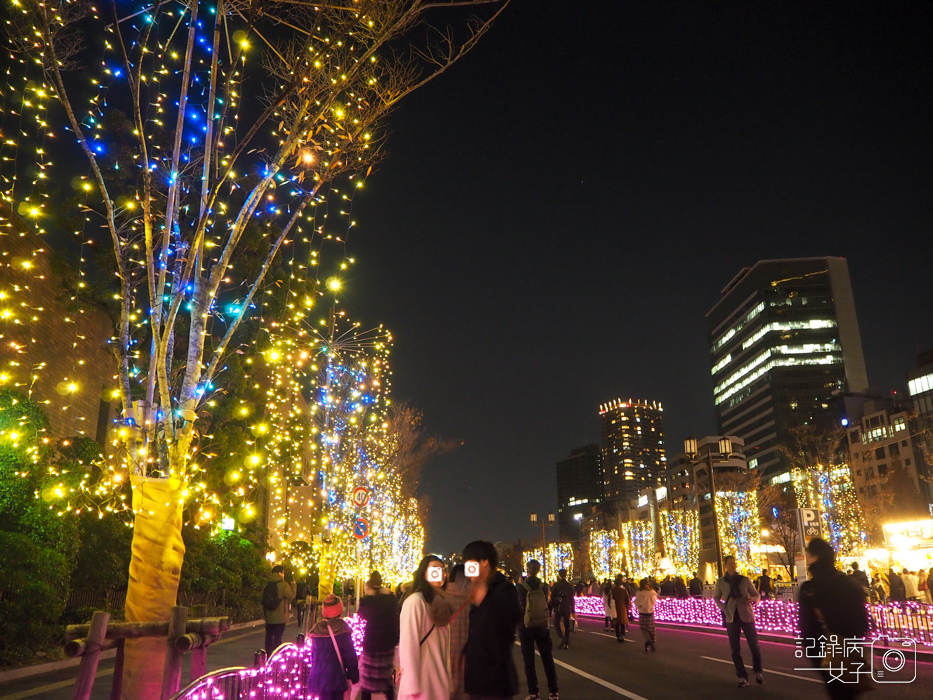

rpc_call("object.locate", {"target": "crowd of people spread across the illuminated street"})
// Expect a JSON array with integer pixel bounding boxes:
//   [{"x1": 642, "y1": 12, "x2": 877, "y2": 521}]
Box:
[{"x1": 255, "y1": 539, "x2": 916, "y2": 700}]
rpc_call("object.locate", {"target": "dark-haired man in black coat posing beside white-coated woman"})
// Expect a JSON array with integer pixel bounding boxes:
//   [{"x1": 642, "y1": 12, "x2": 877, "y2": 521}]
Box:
[{"x1": 463, "y1": 540, "x2": 522, "y2": 700}]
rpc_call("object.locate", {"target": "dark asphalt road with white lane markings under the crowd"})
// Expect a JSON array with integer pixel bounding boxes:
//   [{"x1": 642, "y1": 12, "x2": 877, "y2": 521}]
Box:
[{"x1": 0, "y1": 619, "x2": 933, "y2": 700}]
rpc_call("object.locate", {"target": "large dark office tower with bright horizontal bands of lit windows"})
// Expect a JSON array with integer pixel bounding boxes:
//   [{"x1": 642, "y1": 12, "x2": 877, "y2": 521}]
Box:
[{"x1": 706, "y1": 257, "x2": 868, "y2": 481}]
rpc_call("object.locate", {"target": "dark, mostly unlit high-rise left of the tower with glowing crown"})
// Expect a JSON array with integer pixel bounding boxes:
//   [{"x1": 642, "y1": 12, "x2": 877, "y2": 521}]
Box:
[{"x1": 557, "y1": 445, "x2": 603, "y2": 542}]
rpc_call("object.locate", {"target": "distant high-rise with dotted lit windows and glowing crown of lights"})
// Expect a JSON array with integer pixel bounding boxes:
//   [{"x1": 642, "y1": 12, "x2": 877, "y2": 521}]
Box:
[{"x1": 599, "y1": 399, "x2": 667, "y2": 505}]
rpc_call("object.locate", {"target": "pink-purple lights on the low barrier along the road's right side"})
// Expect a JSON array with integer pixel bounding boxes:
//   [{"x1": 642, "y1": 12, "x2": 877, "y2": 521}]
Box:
[{"x1": 574, "y1": 596, "x2": 933, "y2": 647}]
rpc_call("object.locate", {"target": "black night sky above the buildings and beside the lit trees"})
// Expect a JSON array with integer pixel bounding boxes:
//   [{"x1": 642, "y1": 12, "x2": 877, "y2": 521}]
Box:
[{"x1": 344, "y1": 0, "x2": 933, "y2": 552}]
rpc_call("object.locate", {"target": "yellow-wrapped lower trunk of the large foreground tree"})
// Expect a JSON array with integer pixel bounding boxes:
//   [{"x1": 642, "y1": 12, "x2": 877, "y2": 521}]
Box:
[{"x1": 122, "y1": 476, "x2": 185, "y2": 700}]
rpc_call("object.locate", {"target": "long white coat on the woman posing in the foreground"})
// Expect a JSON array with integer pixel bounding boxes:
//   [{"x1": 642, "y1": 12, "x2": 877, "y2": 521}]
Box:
[{"x1": 398, "y1": 592, "x2": 450, "y2": 700}]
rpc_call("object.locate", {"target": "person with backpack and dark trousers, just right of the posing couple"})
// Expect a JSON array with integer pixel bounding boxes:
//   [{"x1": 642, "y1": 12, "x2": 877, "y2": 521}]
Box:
[{"x1": 518, "y1": 559, "x2": 558, "y2": 700}]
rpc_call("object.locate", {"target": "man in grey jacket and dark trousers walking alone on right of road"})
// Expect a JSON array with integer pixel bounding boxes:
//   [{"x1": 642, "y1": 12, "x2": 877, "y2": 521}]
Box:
[{"x1": 713, "y1": 554, "x2": 765, "y2": 688}]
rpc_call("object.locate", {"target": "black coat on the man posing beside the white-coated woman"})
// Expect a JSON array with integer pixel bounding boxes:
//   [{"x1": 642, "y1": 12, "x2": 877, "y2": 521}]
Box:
[{"x1": 463, "y1": 571, "x2": 524, "y2": 698}]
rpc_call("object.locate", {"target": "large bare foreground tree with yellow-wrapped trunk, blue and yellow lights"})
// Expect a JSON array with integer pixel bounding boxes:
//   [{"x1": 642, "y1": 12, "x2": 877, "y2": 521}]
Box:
[{"x1": 8, "y1": 0, "x2": 507, "y2": 697}]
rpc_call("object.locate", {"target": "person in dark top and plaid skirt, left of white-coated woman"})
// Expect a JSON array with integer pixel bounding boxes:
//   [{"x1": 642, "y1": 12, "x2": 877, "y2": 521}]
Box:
[{"x1": 359, "y1": 571, "x2": 399, "y2": 700}]
